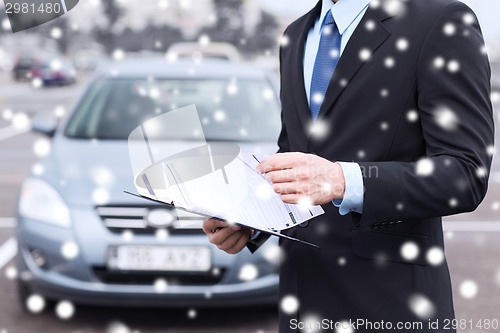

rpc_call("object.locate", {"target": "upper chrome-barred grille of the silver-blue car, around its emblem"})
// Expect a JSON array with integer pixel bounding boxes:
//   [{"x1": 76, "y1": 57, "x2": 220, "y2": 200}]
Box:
[{"x1": 96, "y1": 205, "x2": 203, "y2": 235}]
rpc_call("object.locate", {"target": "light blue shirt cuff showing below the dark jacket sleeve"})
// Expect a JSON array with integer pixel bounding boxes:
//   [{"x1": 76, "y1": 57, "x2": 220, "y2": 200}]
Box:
[{"x1": 333, "y1": 162, "x2": 364, "y2": 215}]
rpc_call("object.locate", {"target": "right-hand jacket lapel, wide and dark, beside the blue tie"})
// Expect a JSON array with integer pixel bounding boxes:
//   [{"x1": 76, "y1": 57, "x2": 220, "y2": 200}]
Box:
[{"x1": 319, "y1": 7, "x2": 392, "y2": 117}]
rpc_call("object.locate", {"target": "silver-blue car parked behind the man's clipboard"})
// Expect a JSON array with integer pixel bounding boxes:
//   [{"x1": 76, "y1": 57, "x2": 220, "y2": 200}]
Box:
[{"x1": 17, "y1": 59, "x2": 280, "y2": 307}]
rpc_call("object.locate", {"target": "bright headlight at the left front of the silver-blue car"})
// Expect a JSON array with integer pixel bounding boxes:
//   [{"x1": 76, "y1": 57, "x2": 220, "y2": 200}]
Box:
[{"x1": 19, "y1": 178, "x2": 71, "y2": 227}]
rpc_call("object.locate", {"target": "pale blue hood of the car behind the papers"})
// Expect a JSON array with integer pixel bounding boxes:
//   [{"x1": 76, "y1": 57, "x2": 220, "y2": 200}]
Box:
[{"x1": 44, "y1": 137, "x2": 277, "y2": 207}]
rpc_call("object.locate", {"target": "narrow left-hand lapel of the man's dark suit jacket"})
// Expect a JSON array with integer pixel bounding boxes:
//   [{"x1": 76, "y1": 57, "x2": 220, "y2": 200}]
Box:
[{"x1": 289, "y1": 1, "x2": 322, "y2": 133}]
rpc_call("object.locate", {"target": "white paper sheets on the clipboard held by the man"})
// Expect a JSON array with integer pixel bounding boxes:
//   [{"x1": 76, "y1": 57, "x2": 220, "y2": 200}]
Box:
[{"x1": 136, "y1": 152, "x2": 324, "y2": 232}]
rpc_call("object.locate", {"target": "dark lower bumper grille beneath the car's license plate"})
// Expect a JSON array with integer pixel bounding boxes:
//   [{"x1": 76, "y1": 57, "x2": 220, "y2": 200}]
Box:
[{"x1": 92, "y1": 267, "x2": 225, "y2": 286}]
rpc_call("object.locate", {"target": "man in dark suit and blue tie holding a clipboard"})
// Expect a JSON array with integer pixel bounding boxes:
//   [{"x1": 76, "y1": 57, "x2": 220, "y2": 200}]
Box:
[{"x1": 204, "y1": 0, "x2": 494, "y2": 333}]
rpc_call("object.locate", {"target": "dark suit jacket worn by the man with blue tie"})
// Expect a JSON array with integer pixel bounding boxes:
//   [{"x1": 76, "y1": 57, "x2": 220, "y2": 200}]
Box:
[{"x1": 254, "y1": 0, "x2": 494, "y2": 333}]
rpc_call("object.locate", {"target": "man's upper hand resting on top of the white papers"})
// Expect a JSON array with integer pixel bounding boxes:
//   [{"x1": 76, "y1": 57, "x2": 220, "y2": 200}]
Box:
[{"x1": 257, "y1": 153, "x2": 345, "y2": 205}]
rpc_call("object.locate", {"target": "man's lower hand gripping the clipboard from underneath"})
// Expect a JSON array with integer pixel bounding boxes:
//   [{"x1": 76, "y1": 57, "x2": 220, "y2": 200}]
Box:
[{"x1": 203, "y1": 218, "x2": 253, "y2": 254}]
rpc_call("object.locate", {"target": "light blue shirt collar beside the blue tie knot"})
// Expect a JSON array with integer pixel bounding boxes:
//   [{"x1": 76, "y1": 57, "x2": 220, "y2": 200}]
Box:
[{"x1": 318, "y1": 0, "x2": 371, "y2": 35}]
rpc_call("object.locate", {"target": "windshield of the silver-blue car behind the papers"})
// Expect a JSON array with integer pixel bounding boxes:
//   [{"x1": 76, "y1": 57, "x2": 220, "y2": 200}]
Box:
[{"x1": 65, "y1": 78, "x2": 281, "y2": 142}]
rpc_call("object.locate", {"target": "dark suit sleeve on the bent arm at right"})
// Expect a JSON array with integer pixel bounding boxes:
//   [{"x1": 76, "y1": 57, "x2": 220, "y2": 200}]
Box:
[{"x1": 360, "y1": 2, "x2": 494, "y2": 227}]
